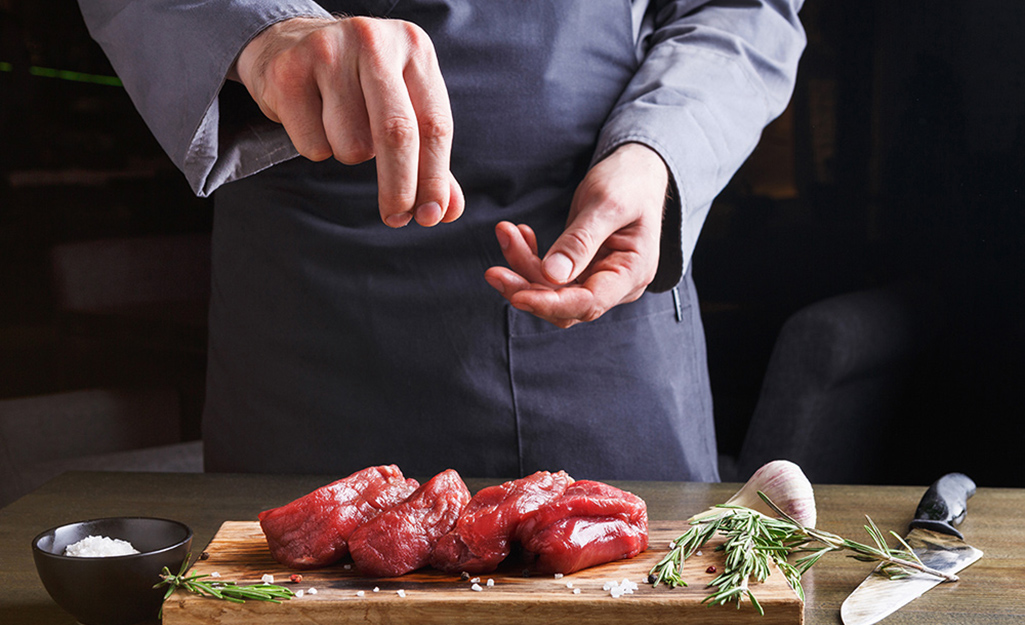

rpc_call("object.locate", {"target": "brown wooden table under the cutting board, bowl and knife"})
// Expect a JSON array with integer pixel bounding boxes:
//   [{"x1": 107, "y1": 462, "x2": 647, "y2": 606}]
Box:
[{"x1": 0, "y1": 473, "x2": 1025, "y2": 625}]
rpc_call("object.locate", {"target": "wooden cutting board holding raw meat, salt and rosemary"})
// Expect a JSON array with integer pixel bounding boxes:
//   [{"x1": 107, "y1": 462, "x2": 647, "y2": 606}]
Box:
[{"x1": 163, "y1": 522, "x2": 804, "y2": 625}]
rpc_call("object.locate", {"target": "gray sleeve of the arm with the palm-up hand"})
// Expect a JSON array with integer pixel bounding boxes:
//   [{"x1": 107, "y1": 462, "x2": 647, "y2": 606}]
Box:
[{"x1": 595, "y1": 0, "x2": 806, "y2": 291}]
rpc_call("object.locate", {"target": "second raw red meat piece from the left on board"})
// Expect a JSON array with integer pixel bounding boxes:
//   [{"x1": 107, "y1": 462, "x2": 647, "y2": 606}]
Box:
[{"x1": 349, "y1": 469, "x2": 469, "y2": 577}]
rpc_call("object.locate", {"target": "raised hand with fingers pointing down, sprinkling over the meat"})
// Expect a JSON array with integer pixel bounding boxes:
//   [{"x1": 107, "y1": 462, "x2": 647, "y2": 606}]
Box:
[{"x1": 233, "y1": 17, "x2": 464, "y2": 227}]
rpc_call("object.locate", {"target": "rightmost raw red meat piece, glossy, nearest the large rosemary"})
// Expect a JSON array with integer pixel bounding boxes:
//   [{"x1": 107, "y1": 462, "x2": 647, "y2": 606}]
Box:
[{"x1": 516, "y1": 480, "x2": 648, "y2": 573}]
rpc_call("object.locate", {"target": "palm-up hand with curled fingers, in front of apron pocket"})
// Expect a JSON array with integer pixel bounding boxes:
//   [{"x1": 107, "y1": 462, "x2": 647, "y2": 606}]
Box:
[{"x1": 485, "y1": 143, "x2": 669, "y2": 328}]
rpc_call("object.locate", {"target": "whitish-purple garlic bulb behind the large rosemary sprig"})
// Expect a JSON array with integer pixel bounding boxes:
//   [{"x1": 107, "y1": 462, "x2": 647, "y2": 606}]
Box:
[{"x1": 691, "y1": 460, "x2": 818, "y2": 528}]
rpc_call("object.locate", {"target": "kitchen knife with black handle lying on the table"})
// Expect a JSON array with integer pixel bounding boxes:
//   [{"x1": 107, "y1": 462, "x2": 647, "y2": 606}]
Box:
[{"x1": 839, "y1": 473, "x2": 982, "y2": 625}]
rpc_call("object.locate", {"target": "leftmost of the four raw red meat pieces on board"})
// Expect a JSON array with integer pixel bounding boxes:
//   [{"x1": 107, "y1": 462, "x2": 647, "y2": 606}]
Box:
[{"x1": 259, "y1": 465, "x2": 419, "y2": 569}]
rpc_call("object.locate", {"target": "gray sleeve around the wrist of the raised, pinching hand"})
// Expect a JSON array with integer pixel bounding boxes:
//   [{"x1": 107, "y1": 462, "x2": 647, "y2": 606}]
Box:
[{"x1": 79, "y1": 0, "x2": 330, "y2": 196}]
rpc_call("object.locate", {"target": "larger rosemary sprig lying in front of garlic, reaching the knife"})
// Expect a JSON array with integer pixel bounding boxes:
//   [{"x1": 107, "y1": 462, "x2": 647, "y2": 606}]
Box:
[{"x1": 648, "y1": 492, "x2": 957, "y2": 614}]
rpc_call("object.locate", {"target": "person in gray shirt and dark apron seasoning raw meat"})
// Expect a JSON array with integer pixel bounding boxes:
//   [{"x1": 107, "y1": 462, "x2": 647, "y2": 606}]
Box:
[{"x1": 80, "y1": 0, "x2": 805, "y2": 481}]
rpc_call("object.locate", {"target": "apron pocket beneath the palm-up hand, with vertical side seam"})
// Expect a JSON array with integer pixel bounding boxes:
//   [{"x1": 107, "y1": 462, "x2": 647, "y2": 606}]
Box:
[{"x1": 509, "y1": 282, "x2": 718, "y2": 481}]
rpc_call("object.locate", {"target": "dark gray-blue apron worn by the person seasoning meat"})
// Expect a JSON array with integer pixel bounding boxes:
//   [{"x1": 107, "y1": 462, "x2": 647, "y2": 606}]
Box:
[{"x1": 204, "y1": 0, "x2": 718, "y2": 481}]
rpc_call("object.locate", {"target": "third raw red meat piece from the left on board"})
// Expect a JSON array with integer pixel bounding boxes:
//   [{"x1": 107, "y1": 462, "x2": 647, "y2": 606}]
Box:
[{"x1": 431, "y1": 471, "x2": 573, "y2": 573}]
